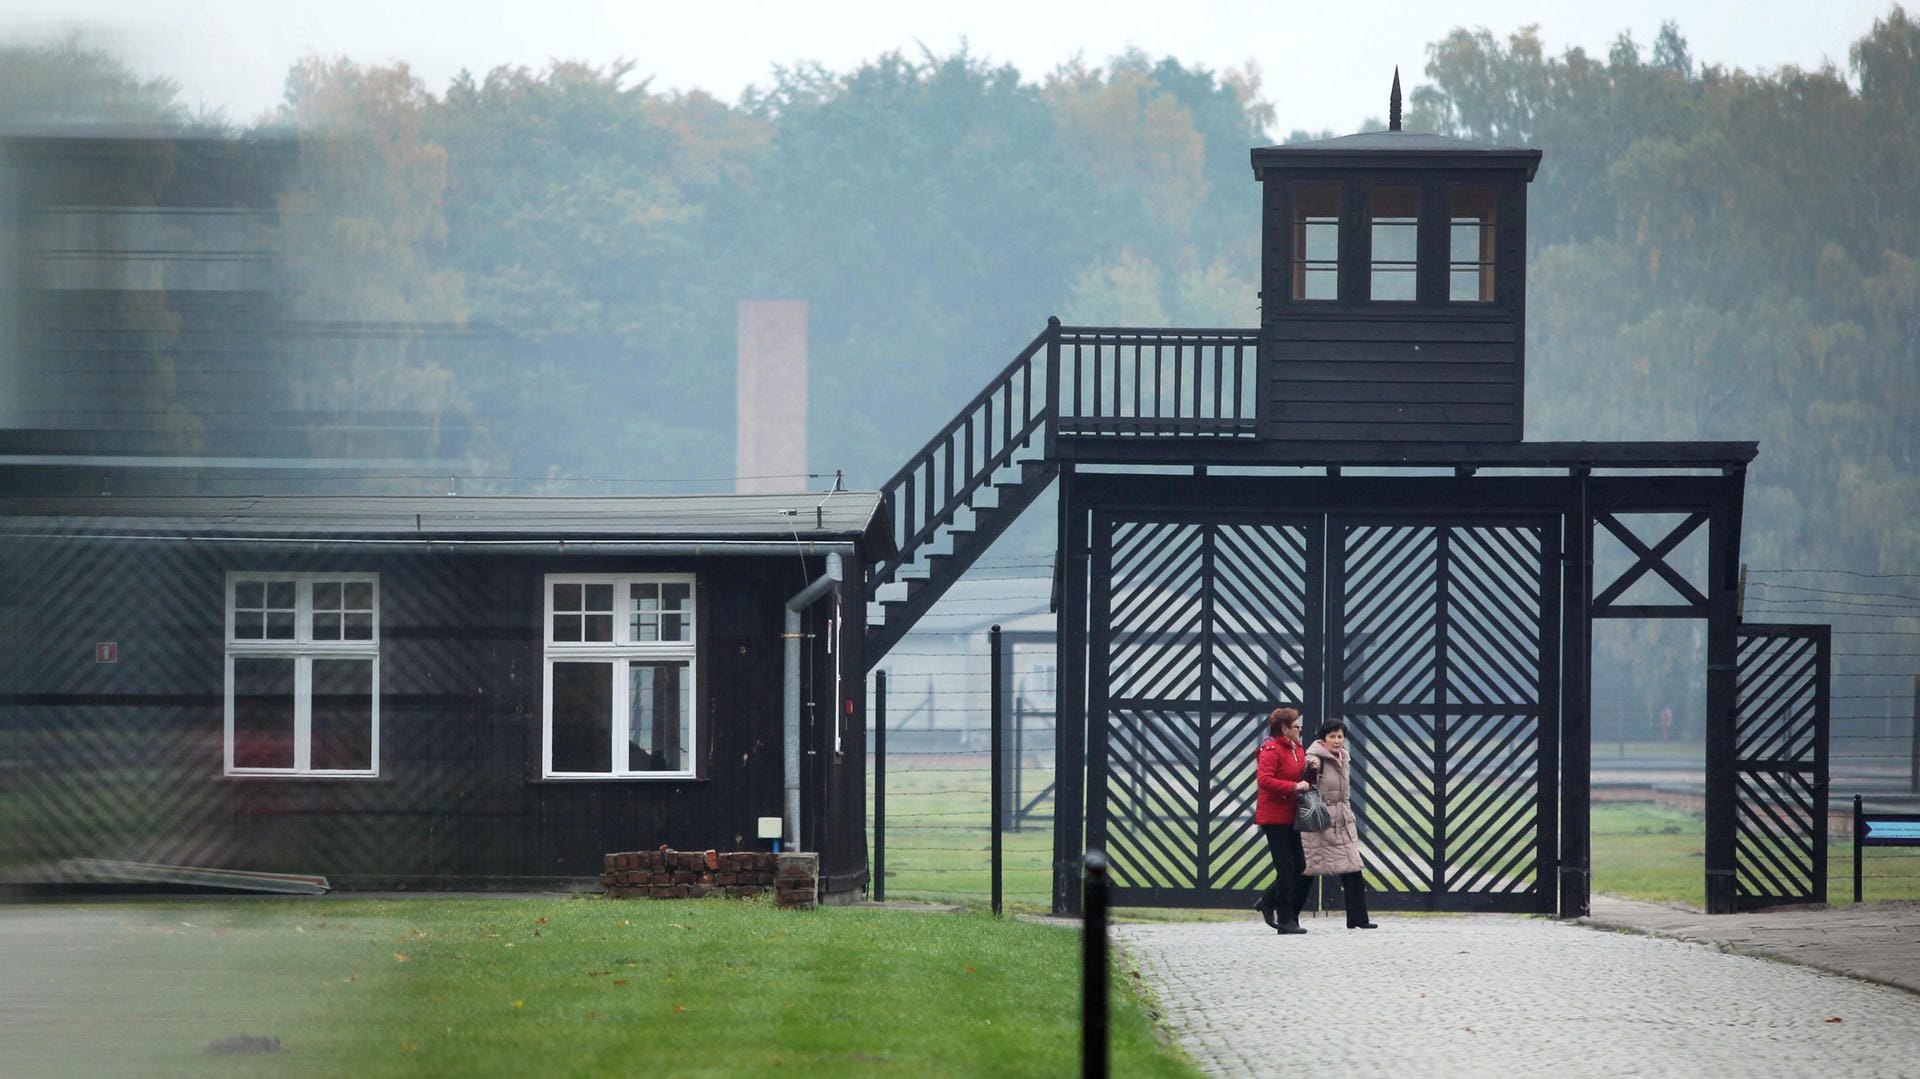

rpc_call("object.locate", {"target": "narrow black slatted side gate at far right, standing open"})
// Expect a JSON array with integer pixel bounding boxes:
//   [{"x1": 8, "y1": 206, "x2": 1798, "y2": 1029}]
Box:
[{"x1": 1734, "y1": 624, "x2": 1832, "y2": 910}]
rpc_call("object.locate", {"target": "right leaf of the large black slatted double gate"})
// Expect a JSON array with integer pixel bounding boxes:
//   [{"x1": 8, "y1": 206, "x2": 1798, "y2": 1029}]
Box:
[{"x1": 1327, "y1": 518, "x2": 1559, "y2": 912}]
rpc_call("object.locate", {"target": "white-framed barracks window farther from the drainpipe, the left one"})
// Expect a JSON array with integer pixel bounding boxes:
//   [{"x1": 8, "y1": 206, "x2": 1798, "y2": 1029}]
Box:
[{"x1": 227, "y1": 572, "x2": 380, "y2": 776}]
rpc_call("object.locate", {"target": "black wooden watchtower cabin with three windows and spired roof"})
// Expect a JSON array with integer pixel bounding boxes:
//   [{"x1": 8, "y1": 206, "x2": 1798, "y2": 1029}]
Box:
[{"x1": 1254, "y1": 79, "x2": 1540, "y2": 444}]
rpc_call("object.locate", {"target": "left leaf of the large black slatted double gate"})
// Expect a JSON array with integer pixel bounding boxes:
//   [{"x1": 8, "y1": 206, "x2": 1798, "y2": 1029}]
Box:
[{"x1": 1087, "y1": 516, "x2": 1323, "y2": 906}]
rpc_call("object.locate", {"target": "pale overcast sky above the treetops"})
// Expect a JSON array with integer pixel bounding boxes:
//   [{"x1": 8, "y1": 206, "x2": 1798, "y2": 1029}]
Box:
[{"x1": 0, "y1": 0, "x2": 1893, "y2": 136}]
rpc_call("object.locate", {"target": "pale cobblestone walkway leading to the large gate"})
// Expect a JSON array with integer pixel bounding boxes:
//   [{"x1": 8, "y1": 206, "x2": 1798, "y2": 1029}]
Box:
[{"x1": 1114, "y1": 900, "x2": 1920, "y2": 1079}]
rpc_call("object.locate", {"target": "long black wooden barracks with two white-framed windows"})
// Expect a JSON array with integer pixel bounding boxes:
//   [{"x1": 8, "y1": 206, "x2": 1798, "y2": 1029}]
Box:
[{"x1": 0, "y1": 492, "x2": 889, "y2": 895}]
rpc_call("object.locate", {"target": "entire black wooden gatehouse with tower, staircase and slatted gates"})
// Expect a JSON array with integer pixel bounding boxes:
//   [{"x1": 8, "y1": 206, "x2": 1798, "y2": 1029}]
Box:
[{"x1": 866, "y1": 75, "x2": 1828, "y2": 916}]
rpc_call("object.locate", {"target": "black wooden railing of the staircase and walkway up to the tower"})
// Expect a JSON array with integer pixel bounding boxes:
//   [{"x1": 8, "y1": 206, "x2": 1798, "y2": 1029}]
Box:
[{"x1": 866, "y1": 319, "x2": 1260, "y2": 645}]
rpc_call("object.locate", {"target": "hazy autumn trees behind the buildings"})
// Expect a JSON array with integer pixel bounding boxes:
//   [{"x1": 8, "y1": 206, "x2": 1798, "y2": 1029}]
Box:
[{"x1": 0, "y1": 14, "x2": 1920, "y2": 706}]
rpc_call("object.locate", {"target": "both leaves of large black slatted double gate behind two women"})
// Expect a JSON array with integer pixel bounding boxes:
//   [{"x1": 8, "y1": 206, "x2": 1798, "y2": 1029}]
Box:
[{"x1": 1087, "y1": 511, "x2": 1559, "y2": 912}]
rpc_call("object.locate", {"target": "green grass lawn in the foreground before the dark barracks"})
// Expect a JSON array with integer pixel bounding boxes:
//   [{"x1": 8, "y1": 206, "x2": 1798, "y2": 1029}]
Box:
[{"x1": 0, "y1": 897, "x2": 1198, "y2": 1077}]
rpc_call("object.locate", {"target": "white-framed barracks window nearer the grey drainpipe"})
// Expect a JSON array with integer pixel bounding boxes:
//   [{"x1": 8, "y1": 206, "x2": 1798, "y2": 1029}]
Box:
[{"x1": 540, "y1": 574, "x2": 699, "y2": 779}]
